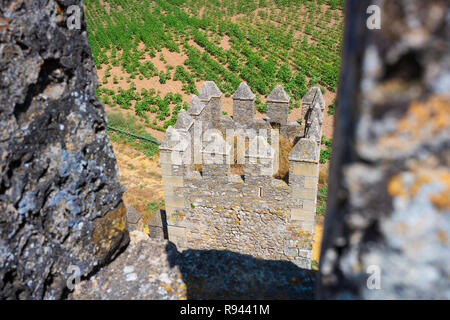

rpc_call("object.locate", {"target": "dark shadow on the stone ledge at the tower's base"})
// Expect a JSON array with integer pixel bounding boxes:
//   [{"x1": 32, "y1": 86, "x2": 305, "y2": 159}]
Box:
[{"x1": 166, "y1": 242, "x2": 316, "y2": 300}]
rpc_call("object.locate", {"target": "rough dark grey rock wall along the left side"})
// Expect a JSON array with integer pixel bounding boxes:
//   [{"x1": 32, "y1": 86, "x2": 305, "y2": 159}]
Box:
[{"x1": 0, "y1": 0, "x2": 127, "y2": 299}]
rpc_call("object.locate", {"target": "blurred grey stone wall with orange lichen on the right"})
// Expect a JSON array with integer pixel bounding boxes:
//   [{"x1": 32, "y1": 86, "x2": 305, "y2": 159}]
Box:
[{"x1": 320, "y1": 0, "x2": 450, "y2": 299}]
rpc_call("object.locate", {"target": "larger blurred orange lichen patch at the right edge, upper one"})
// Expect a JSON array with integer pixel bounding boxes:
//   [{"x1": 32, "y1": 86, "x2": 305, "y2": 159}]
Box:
[{"x1": 379, "y1": 96, "x2": 450, "y2": 150}]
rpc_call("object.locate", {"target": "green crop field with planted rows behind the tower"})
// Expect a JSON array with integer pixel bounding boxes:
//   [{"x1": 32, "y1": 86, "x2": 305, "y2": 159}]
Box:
[{"x1": 85, "y1": 0, "x2": 343, "y2": 131}]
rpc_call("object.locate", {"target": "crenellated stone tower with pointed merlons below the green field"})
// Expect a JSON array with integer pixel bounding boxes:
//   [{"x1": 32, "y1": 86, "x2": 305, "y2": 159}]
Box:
[{"x1": 158, "y1": 81, "x2": 324, "y2": 268}]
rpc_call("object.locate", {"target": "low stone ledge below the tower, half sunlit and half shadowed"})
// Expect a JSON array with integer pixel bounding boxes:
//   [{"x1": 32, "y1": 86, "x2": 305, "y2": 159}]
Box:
[{"x1": 69, "y1": 231, "x2": 315, "y2": 299}]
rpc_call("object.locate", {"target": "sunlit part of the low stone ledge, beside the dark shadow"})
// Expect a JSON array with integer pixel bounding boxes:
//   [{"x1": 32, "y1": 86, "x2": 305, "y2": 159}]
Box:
[{"x1": 68, "y1": 231, "x2": 187, "y2": 300}]
